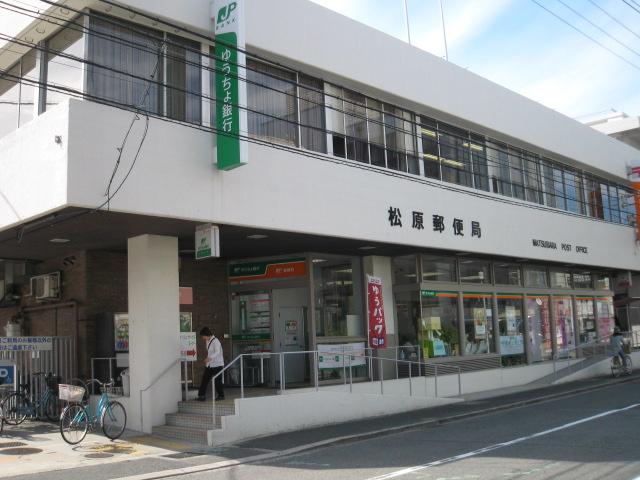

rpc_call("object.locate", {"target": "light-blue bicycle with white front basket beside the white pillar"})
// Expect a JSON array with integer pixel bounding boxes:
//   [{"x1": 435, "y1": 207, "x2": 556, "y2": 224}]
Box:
[{"x1": 60, "y1": 379, "x2": 127, "y2": 445}]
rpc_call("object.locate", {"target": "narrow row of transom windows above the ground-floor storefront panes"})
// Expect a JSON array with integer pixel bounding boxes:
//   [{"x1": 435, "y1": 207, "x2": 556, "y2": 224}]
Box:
[{"x1": 392, "y1": 254, "x2": 611, "y2": 290}]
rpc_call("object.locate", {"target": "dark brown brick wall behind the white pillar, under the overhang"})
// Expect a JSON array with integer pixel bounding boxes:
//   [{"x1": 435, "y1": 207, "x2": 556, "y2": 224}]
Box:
[{"x1": 0, "y1": 251, "x2": 231, "y2": 383}]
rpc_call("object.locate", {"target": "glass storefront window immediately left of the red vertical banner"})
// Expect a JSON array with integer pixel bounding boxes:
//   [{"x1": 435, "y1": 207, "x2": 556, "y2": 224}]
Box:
[{"x1": 313, "y1": 257, "x2": 362, "y2": 337}]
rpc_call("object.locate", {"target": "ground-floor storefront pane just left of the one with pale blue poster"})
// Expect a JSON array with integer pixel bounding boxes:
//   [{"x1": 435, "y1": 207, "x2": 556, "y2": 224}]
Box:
[{"x1": 463, "y1": 295, "x2": 495, "y2": 355}]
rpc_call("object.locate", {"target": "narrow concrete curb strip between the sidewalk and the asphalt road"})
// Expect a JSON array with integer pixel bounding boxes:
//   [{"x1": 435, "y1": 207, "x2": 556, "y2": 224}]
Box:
[{"x1": 113, "y1": 377, "x2": 640, "y2": 480}]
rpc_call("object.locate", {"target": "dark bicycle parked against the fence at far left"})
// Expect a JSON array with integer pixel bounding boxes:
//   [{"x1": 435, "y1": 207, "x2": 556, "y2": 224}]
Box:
[{"x1": 0, "y1": 372, "x2": 60, "y2": 425}]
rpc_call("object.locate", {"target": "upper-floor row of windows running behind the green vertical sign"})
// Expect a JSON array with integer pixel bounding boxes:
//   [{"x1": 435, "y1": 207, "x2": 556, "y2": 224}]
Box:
[{"x1": 0, "y1": 12, "x2": 635, "y2": 224}]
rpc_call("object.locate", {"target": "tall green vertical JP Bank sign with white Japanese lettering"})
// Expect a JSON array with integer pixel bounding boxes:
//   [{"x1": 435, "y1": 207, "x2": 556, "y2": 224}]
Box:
[{"x1": 212, "y1": 0, "x2": 247, "y2": 170}]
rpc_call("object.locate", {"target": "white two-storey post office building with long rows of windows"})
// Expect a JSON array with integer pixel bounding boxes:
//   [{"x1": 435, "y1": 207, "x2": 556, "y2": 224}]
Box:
[{"x1": 0, "y1": 0, "x2": 640, "y2": 436}]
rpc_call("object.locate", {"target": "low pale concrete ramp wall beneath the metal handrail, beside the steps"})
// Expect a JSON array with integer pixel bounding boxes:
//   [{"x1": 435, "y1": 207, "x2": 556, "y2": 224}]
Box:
[{"x1": 209, "y1": 363, "x2": 568, "y2": 445}]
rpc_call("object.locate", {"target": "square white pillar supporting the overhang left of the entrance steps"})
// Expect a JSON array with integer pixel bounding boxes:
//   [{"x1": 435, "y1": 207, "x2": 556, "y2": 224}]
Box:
[{"x1": 127, "y1": 235, "x2": 181, "y2": 433}]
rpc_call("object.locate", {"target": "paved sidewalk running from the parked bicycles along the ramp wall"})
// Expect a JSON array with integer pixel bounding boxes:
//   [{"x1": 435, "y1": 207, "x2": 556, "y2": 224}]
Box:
[{"x1": 6, "y1": 374, "x2": 640, "y2": 480}]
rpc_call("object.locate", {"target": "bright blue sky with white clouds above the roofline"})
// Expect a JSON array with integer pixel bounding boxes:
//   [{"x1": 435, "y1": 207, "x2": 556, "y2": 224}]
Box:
[{"x1": 312, "y1": 0, "x2": 640, "y2": 118}]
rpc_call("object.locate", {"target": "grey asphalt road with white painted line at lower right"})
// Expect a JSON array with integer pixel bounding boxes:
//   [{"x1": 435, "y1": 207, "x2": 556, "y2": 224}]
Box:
[{"x1": 171, "y1": 382, "x2": 640, "y2": 480}]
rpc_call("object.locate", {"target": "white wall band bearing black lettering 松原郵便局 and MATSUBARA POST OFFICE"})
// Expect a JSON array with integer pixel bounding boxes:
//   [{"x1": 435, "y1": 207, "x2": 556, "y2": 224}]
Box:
[{"x1": 63, "y1": 101, "x2": 640, "y2": 270}]
